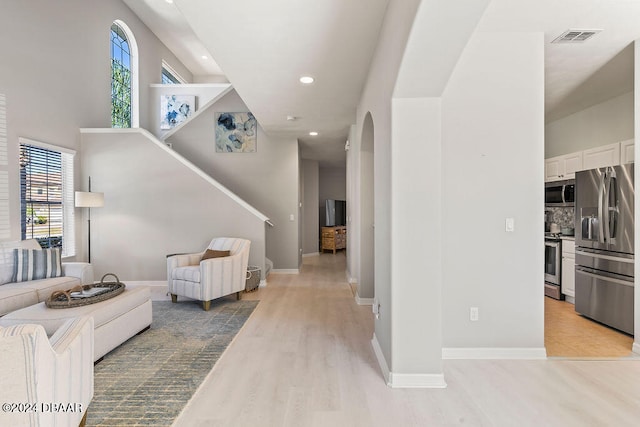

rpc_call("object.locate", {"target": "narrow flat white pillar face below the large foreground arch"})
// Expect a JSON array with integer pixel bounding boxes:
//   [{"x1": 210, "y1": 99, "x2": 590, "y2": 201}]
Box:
[{"x1": 390, "y1": 97, "x2": 448, "y2": 378}]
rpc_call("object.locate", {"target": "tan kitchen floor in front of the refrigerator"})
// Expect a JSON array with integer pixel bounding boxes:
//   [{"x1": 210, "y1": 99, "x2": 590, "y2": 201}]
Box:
[{"x1": 544, "y1": 297, "x2": 633, "y2": 358}]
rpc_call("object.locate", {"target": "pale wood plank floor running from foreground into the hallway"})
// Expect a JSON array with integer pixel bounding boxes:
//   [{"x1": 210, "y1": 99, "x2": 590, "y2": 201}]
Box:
[{"x1": 175, "y1": 254, "x2": 640, "y2": 427}]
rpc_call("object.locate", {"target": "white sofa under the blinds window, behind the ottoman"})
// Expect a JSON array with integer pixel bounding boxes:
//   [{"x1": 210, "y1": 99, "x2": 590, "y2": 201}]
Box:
[{"x1": 0, "y1": 239, "x2": 93, "y2": 316}]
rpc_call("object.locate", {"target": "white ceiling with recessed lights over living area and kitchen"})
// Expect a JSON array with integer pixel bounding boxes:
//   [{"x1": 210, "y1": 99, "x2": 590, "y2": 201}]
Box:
[{"x1": 123, "y1": 0, "x2": 640, "y2": 167}]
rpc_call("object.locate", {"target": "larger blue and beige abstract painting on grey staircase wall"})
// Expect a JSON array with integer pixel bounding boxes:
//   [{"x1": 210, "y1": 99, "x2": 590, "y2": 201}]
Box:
[{"x1": 215, "y1": 113, "x2": 258, "y2": 153}]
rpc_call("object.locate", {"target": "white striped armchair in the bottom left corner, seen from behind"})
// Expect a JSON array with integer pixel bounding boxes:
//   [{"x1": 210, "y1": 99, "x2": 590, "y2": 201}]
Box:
[{"x1": 0, "y1": 316, "x2": 93, "y2": 427}]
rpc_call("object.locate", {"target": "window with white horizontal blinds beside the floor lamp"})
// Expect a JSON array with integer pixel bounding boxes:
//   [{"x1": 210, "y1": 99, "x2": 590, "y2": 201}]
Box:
[{"x1": 20, "y1": 138, "x2": 75, "y2": 256}]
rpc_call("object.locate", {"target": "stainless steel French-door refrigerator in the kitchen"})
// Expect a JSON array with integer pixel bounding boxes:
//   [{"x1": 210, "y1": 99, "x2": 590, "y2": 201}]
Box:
[{"x1": 575, "y1": 164, "x2": 634, "y2": 335}]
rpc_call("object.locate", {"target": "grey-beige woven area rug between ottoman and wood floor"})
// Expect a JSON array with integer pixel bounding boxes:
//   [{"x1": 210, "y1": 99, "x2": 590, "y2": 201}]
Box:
[{"x1": 86, "y1": 296, "x2": 258, "y2": 426}]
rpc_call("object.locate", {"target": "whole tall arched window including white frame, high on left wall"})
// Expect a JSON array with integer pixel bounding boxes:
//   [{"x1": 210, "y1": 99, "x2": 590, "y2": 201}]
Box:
[{"x1": 111, "y1": 21, "x2": 139, "y2": 128}]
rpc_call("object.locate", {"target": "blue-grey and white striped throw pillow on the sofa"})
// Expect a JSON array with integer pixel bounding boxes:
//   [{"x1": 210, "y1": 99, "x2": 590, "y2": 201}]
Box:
[{"x1": 12, "y1": 248, "x2": 62, "y2": 282}]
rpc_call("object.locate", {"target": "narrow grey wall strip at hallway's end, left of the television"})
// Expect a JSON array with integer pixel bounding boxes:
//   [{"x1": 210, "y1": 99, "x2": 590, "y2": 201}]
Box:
[{"x1": 302, "y1": 160, "x2": 320, "y2": 254}]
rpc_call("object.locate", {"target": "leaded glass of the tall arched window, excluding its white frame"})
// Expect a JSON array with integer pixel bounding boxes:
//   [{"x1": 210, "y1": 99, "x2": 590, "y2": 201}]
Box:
[{"x1": 111, "y1": 22, "x2": 131, "y2": 128}]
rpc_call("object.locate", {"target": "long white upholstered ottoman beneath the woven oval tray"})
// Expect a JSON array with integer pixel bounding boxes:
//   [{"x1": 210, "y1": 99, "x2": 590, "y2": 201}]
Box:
[{"x1": 0, "y1": 286, "x2": 153, "y2": 361}]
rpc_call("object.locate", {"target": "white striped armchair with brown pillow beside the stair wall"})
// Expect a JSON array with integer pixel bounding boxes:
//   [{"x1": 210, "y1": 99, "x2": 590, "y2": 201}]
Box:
[{"x1": 167, "y1": 237, "x2": 251, "y2": 311}]
